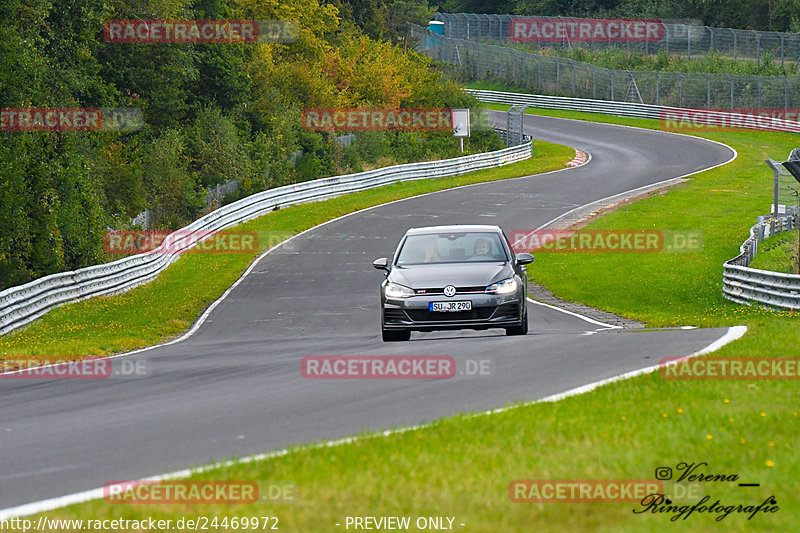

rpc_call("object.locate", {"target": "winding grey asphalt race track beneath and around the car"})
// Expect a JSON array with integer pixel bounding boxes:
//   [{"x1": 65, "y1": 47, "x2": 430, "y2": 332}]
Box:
[{"x1": 0, "y1": 115, "x2": 733, "y2": 508}]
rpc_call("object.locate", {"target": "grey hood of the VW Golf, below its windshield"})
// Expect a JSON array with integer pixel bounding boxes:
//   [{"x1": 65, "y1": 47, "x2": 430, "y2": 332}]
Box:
[{"x1": 389, "y1": 261, "x2": 514, "y2": 289}]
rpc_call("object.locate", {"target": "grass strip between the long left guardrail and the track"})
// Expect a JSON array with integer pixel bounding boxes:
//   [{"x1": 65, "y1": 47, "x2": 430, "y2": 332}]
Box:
[{"x1": 0, "y1": 142, "x2": 575, "y2": 360}]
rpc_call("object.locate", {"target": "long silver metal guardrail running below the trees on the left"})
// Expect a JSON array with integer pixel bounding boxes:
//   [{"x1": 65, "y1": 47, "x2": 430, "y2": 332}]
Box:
[{"x1": 0, "y1": 143, "x2": 533, "y2": 335}]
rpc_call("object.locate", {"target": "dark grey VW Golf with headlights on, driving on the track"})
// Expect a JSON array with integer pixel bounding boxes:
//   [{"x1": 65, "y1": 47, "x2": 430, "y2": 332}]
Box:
[{"x1": 372, "y1": 225, "x2": 533, "y2": 341}]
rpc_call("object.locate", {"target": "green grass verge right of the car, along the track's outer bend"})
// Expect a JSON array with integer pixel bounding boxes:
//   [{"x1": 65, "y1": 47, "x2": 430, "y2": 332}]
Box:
[{"x1": 478, "y1": 104, "x2": 800, "y2": 344}]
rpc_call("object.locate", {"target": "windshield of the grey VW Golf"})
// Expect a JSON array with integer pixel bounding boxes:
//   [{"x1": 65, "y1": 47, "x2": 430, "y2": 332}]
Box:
[{"x1": 397, "y1": 232, "x2": 508, "y2": 266}]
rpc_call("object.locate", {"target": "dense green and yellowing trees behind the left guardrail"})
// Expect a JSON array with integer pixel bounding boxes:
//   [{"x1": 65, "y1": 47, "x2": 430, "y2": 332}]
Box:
[{"x1": 0, "y1": 0, "x2": 499, "y2": 289}]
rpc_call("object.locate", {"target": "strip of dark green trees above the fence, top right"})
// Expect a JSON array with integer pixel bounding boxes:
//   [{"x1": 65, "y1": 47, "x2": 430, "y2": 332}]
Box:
[{"x1": 438, "y1": 0, "x2": 800, "y2": 32}]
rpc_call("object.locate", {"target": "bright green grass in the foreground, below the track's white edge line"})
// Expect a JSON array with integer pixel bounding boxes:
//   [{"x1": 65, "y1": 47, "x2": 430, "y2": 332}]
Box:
[{"x1": 21, "y1": 362, "x2": 800, "y2": 533}]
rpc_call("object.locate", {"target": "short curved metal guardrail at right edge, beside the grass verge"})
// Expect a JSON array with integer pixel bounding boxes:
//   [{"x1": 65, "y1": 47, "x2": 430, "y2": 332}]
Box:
[{"x1": 722, "y1": 215, "x2": 800, "y2": 310}]
